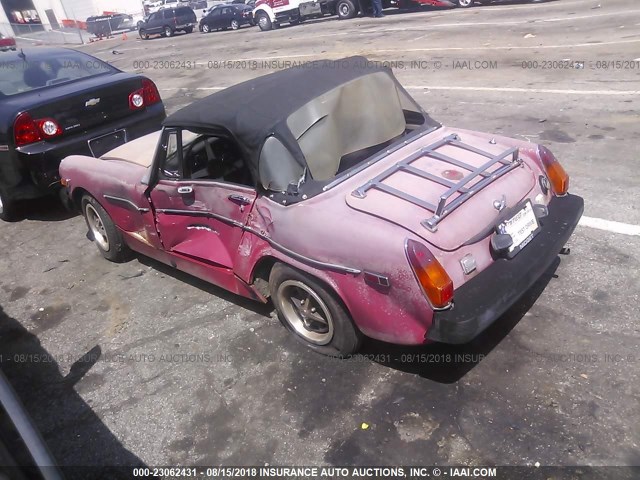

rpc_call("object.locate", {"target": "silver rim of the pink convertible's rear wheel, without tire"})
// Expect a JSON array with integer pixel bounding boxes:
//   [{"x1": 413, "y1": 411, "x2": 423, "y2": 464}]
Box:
[{"x1": 276, "y1": 280, "x2": 333, "y2": 345}]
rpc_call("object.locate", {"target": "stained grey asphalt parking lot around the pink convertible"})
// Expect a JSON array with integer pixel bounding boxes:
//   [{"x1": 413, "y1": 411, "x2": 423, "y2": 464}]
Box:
[{"x1": 0, "y1": 0, "x2": 640, "y2": 474}]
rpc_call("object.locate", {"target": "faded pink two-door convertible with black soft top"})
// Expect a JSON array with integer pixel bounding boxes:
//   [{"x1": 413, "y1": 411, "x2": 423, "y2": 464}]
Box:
[{"x1": 60, "y1": 57, "x2": 583, "y2": 356}]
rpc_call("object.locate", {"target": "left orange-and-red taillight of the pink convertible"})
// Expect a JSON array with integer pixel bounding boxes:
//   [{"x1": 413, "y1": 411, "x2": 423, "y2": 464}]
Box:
[{"x1": 405, "y1": 240, "x2": 453, "y2": 308}]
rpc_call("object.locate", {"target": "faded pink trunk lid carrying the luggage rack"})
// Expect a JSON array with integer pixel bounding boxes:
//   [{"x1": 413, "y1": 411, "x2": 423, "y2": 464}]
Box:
[{"x1": 346, "y1": 132, "x2": 535, "y2": 251}]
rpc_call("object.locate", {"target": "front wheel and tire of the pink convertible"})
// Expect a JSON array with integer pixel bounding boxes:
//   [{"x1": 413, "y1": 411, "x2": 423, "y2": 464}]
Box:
[{"x1": 81, "y1": 195, "x2": 132, "y2": 263}]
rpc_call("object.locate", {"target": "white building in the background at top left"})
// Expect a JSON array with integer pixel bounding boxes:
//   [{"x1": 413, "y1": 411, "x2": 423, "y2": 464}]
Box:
[{"x1": 0, "y1": 0, "x2": 143, "y2": 35}]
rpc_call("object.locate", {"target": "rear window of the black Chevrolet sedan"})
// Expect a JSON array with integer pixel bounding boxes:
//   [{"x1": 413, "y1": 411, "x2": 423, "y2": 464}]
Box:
[{"x1": 0, "y1": 52, "x2": 117, "y2": 97}]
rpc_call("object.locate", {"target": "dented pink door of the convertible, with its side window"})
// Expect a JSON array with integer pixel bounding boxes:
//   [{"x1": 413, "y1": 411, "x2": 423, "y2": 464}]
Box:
[{"x1": 151, "y1": 129, "x2": 256, "y2": 278}]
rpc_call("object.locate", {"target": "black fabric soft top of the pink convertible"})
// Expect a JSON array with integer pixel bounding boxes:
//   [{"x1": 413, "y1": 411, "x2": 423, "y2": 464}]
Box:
[{"x1": 164, "y1": 57, "x2": 432, "y2": 190}]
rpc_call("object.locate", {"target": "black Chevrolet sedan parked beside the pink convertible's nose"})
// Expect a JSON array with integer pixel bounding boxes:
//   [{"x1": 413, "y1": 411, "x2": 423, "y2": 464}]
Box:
[{"x1": 0, "y1": 48, "x2": 166, "y2": 220}]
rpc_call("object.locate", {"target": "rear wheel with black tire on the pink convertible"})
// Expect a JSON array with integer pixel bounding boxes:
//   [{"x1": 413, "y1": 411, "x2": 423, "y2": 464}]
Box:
[{"x1": 269, "y1": 263, "x2": 363, "y2": 357}]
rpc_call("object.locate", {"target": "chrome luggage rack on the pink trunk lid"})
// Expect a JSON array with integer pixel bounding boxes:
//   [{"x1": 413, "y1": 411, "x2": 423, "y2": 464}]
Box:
[{"x1": 351, "y1": 133, "x2": 522, "y2": 232}]
